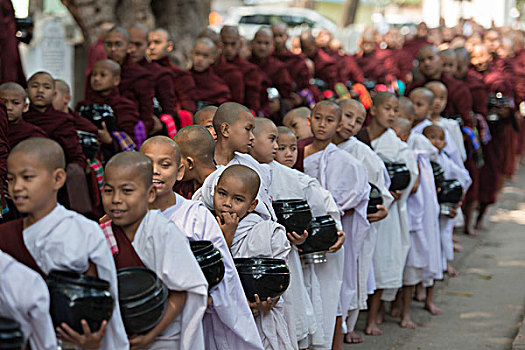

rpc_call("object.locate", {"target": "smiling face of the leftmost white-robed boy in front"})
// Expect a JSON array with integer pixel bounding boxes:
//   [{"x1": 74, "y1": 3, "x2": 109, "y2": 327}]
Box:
[{"x1": 7, "y1": 152, "x2": 66, "y2": 217}]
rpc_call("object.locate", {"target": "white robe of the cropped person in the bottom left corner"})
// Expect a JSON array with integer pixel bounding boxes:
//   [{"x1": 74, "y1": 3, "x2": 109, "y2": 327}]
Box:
[{"x1": 0, "y1": 251, "x2": 57, "y2": 350}]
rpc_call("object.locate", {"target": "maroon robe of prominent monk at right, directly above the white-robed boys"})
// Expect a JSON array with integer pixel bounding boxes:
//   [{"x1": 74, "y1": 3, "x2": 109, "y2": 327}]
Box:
[{"x1": 405, "y1": 73, "x2": 474, "y2": 128}]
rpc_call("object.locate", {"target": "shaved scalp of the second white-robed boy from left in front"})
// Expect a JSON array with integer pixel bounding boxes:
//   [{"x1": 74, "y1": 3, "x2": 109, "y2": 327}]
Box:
[{"x1": 104, "y1": 151, "x2": 153, "y2": 188}]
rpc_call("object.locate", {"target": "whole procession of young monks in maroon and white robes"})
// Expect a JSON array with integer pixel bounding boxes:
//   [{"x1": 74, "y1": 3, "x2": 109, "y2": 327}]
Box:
[{"x1": 0, "y1": 16, "x2": 525, "y2": 349}]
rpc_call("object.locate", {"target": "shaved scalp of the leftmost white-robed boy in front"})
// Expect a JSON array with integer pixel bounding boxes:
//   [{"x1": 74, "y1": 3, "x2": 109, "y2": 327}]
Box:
[{"x1": 9, "y1": 137, "x2": 66, "y2": 172}]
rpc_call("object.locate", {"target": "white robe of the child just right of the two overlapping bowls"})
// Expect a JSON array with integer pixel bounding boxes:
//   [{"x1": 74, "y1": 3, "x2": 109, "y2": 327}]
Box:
[{"x1": 304, "y1": 143, "x2": 370, "y2": 331}]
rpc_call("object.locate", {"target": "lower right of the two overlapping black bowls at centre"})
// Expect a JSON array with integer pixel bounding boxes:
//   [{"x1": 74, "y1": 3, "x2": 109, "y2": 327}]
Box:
[{"x1": 299, "y1": 215, "x2": 337, "y2": 254}]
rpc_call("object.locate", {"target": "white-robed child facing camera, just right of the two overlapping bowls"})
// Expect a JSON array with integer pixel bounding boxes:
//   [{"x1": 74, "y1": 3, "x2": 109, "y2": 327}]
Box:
[{"x1": 304, "y1": 101, "x2": 370, "y2": 349}]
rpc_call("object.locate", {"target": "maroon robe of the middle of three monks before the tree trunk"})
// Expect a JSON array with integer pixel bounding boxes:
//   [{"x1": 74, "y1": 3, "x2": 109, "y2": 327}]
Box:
[{"x1": 137, "y1": 58, "x2": 177, "y2": 116}]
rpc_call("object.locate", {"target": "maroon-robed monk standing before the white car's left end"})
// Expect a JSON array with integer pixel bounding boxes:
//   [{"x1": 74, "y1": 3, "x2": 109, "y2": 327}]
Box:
[{"x1": 218, "y1": 26, "x2": 262, "y2": 112}]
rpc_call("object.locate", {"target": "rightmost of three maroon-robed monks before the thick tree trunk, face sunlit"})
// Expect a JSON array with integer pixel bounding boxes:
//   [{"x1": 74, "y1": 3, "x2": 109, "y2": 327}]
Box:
[{"x1": 147, "y1": 28, "x2": 196, "y2": 114}]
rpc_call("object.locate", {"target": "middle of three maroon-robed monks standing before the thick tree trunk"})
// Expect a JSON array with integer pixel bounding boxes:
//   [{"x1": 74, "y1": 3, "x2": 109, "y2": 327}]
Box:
[{"x1": 128, "y1": 24, "x2": 178, "y2": 118}]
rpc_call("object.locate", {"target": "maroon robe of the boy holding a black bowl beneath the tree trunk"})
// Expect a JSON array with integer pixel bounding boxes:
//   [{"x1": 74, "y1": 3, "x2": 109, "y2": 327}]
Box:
[{"x1": 75, "y1": 88, "x2": 140, "y2": 138}]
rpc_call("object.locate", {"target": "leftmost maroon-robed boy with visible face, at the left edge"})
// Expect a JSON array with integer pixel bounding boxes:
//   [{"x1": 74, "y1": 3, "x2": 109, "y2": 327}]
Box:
[{"x1": 0, "y1": 83, "x2": 47, "y2": 148}]
